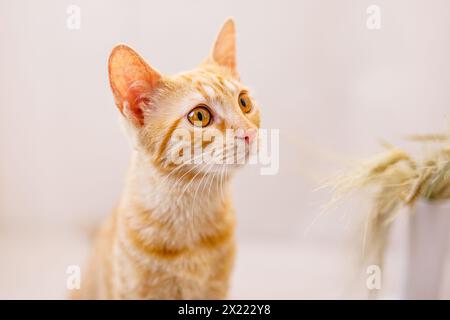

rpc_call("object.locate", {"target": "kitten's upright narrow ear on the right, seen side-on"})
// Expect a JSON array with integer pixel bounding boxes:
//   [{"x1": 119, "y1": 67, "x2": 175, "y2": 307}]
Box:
[{"x1": 210, "y1": 18, "x2": 237, "y2": 75}]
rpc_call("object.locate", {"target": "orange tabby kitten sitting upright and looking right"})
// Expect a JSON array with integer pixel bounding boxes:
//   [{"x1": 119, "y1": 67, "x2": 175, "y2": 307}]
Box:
[{"x1": 73, "y1": 19, "x2": 260, "y2": 299}]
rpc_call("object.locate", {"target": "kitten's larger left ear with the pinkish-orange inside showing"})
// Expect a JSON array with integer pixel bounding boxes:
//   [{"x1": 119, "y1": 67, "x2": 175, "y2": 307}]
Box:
[{"x1": 108, "y1": 45, "x2": 161, "y2": 125}]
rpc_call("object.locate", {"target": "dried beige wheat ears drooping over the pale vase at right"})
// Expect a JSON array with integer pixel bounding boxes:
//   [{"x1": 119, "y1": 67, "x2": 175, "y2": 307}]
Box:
[{"x1": 327, "y1": 135, "x2": 450, "y2": 266}]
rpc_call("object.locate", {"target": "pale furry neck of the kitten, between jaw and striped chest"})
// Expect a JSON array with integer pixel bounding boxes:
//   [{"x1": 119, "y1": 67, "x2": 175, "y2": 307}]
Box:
[{"x1": 121, "y1": 151, "x2": 230, "y2": 222}]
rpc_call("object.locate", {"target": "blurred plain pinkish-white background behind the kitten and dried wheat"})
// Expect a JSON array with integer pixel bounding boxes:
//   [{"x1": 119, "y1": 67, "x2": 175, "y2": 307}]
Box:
[{"x1": 0, "y1": 0, "x2": 450, "y2": 299}]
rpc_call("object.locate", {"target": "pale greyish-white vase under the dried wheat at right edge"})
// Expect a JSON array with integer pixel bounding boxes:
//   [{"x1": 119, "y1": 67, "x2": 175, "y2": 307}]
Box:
[{"x1": 405, "y1": 200, "x2": 450, "y2": 299}]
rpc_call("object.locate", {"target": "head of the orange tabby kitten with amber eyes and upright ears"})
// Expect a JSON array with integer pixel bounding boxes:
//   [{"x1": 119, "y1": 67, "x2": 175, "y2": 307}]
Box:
[{"x1": 109, "y1": 19, "x2": 260, "y2": 173}]
